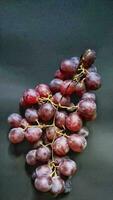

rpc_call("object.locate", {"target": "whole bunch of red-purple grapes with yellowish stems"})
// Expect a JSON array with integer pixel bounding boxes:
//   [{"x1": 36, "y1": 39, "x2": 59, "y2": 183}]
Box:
[{"x1": 8, "y1": 49, "x2": 101, "y2": 195}]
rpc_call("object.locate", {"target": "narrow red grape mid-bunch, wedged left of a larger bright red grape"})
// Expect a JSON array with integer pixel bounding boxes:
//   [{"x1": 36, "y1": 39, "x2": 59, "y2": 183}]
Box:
[{"x1": 55, "y1": 111, "x2": 67, "y2": 129}]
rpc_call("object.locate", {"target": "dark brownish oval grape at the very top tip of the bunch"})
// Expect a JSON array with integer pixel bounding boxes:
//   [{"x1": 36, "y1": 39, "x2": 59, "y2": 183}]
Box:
[{"x1": 81, "y1": 49, "x2": 96, "y2": 69}]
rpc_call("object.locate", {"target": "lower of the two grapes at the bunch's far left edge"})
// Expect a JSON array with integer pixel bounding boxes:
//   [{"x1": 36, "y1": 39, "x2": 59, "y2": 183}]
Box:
[{"x1": 8, "y1": 128, "x2": 24, "y2": 144}]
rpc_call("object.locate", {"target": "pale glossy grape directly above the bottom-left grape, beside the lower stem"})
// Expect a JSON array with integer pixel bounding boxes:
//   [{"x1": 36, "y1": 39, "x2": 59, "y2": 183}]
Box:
[{"x1": 35, "y1": 164, "x2": 52, "y2": 178}]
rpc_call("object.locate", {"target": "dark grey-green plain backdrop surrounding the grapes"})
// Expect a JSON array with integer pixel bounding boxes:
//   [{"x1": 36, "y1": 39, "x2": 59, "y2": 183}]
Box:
[{"x1": 0, "y1": 0, "x2": 113, "y2": 200}]
